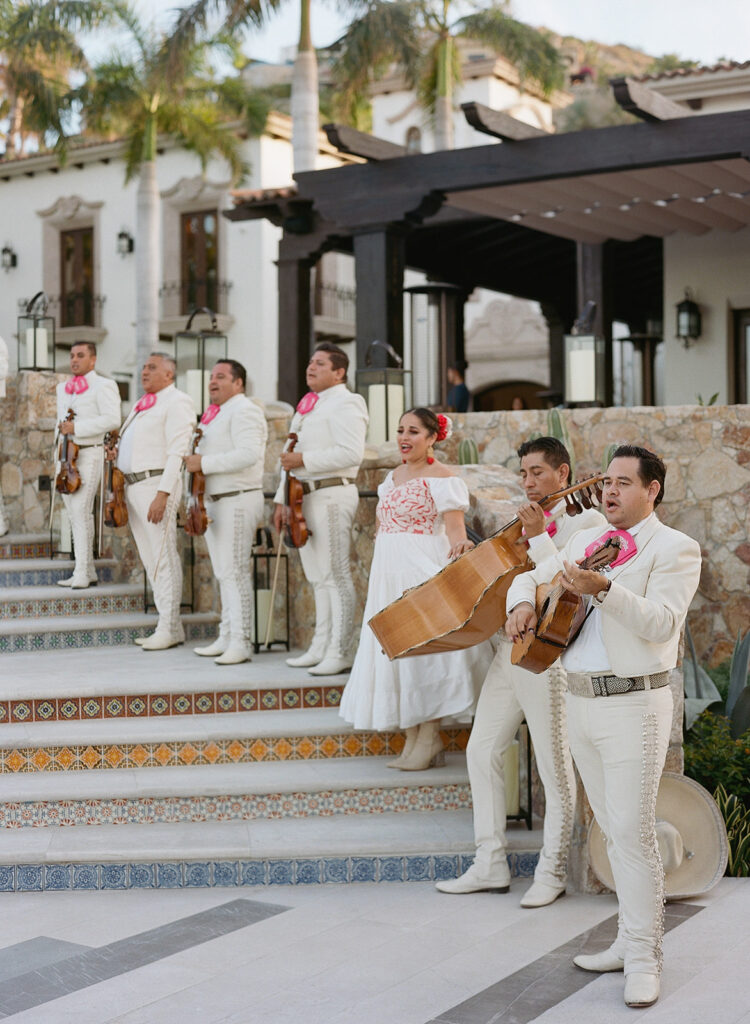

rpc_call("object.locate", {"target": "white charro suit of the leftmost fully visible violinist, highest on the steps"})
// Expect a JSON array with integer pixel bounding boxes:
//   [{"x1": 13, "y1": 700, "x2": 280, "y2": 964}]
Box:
[{"x1": 55, "y1": 370, "x2": 121, "y2": 586}]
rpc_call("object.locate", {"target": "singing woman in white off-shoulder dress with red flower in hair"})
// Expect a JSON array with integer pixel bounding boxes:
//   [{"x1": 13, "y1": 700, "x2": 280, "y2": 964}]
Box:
[{"x1": 340, "y1": 409, "x2": 493, "y2": 771}]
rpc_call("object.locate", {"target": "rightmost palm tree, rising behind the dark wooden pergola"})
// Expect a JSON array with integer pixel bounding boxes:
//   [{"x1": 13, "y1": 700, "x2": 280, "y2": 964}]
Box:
[{"x1": 333, "y1": 0, "x2": 564, "y2": 150}]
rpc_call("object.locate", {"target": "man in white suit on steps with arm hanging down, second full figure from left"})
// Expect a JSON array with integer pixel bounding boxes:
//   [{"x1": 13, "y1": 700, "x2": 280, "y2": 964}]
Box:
[{"x1": 117, "y1": 352, "x2": 196, "y2": 650}]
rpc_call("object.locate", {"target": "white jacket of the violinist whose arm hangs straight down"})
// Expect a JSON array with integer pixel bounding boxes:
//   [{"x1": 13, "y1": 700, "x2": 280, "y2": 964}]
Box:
[{"x1": 118, "y1": 384, "x2": 196, "y2": 495}]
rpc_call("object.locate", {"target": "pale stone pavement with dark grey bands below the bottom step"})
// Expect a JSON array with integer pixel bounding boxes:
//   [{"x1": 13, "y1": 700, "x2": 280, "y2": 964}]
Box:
[{"x1": 0, "y1": 879, "x2": 750, "y2": 1024}]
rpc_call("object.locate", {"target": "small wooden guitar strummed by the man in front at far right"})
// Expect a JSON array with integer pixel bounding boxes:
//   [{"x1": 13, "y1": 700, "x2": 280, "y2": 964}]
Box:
[{"x1": 510, "y1": 538, "x2": 620, "y2": 674}]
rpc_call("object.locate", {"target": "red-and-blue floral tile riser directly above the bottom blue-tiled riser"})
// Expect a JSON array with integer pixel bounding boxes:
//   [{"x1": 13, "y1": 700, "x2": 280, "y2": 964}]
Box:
[{"x1": 0, "y1": 783, "x2": 471, "y2": 829}]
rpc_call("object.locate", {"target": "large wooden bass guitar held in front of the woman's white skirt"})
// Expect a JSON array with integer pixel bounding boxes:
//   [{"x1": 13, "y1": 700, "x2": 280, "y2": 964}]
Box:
[{"x1": 368, "y1": 475, "x2": 603, "y2": 660}]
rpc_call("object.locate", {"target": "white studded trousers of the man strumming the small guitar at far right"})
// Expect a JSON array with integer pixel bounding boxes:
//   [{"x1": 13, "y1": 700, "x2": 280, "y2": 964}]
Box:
[{"x1": 568, "y1": 686, "x2": 672, "y2": 975}]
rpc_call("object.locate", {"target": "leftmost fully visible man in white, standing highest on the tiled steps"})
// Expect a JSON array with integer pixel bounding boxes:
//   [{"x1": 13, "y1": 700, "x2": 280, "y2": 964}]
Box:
[{"x1": 56, "y1": 341, "x2": 121, "y2": 590}]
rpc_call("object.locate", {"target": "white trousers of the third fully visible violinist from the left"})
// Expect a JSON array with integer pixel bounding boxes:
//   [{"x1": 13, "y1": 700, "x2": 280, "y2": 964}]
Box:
[{"x1": 206, "y1": 490, "x2": 263, "y2": 647}]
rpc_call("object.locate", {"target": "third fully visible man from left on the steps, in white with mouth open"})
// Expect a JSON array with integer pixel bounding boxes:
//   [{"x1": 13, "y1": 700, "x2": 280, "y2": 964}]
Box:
[{"x1": 184, "y1": 359, "x2": 267, "y2": 665}]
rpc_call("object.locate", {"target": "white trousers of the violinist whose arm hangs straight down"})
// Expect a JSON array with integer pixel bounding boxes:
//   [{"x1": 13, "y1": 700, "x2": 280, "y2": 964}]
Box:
[{"x1": 125, "y1": 476, "x2": 184, "y2": 640}]
